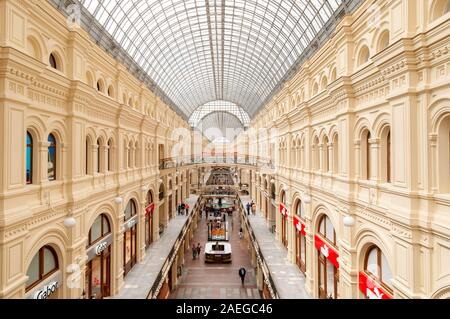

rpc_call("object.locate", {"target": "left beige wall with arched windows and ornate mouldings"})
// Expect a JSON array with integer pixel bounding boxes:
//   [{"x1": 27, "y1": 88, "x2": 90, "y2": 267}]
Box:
[{"x1": 0, "y1": 0, "x2": 189, "y2": 298}]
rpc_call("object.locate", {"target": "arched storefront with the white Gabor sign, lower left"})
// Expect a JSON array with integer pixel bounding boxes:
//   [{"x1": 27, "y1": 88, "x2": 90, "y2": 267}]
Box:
[{"x1": 25, "y1": 245, "x2": 63, "y2": 299}]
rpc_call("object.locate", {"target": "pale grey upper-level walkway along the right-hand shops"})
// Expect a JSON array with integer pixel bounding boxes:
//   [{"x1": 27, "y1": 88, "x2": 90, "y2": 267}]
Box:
[{"x1": 240, "y1": 196, "x2": 311, "y2": 299}]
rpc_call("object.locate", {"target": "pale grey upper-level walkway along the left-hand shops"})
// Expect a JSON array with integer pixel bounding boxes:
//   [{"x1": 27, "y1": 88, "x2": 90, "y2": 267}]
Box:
[{"x1": 111, "y1": 195, "x2": 198, "y2": 299}]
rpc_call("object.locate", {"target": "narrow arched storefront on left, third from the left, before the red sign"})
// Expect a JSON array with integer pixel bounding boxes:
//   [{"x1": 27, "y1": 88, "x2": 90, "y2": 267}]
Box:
[{"x1": 123, "y1": 199, "x2": 139, "y2": 276}]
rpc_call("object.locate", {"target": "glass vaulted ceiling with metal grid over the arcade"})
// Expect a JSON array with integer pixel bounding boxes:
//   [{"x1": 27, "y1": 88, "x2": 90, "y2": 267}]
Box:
[{"x1": 80, "y1": 0, "x2": 342, "y2": 122}]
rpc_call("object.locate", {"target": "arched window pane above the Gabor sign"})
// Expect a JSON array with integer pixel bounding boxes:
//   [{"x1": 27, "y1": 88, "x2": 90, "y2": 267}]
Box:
[{"x1": 25, "y1": 245, "x2": 58, "y2": 291}]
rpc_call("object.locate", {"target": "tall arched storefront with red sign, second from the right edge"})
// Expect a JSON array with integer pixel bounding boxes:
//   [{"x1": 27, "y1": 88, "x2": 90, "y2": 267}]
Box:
[{"x1": 314, "y1": 215, "x2": 339, "y2": 299}]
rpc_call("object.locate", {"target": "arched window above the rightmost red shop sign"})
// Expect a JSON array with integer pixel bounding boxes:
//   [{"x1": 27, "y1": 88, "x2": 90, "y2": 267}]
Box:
[{"x1": 364, "y1": 246, "x2": 393, "y2": 293}]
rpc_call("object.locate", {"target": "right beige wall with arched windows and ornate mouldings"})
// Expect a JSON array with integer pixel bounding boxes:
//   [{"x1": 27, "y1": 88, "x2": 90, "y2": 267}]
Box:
[{"x1": 243, "y1": 0, "x2": 450, "y2": 298}]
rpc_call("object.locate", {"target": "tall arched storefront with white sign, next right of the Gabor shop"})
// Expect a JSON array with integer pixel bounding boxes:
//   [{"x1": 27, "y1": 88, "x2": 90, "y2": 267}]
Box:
[{"x1": 84, "y1": 214, "x2": 113, "y2": 299}]
